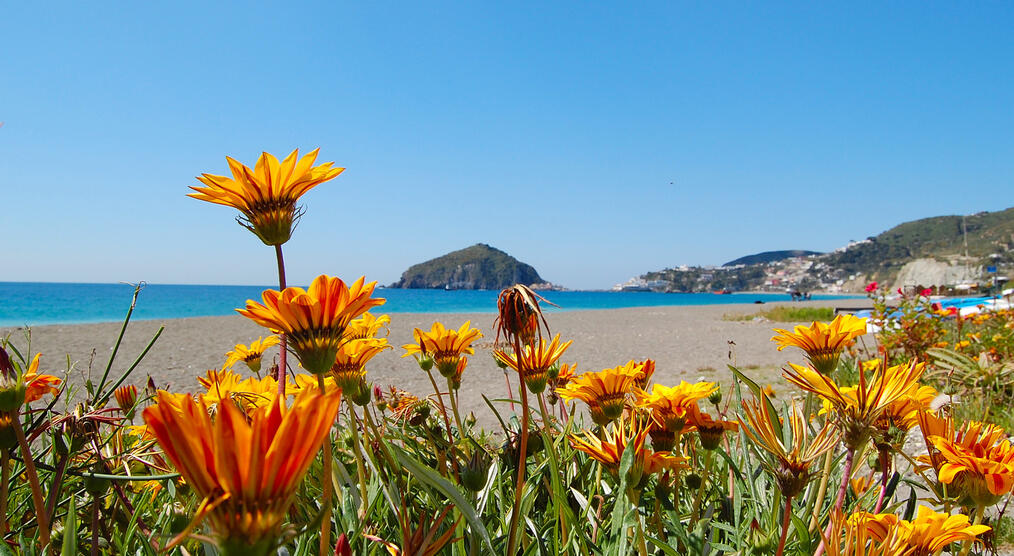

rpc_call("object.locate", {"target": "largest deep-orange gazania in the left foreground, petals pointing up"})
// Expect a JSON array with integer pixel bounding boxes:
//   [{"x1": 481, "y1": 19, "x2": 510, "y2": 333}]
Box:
[{"x1": 144, "y1": 391, "x2": 341, "y2": 556}]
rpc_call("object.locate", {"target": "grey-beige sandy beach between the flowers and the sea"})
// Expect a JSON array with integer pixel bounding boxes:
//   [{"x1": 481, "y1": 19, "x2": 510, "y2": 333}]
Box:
[{"x1": 0, "y1": 299, "x2": 867, "y2": 425}]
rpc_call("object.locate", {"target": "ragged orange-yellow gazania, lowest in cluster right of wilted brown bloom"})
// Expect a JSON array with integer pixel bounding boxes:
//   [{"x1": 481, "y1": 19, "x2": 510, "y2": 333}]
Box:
[{"x1": 571, "y1": 415, "x2": 686, "y2": 486}]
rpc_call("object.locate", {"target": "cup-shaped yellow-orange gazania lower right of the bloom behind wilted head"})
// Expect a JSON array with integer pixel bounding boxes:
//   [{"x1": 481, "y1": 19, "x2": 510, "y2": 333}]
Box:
[{"x1": 557, "y1": 361, "x2": 640, "y2": 425}]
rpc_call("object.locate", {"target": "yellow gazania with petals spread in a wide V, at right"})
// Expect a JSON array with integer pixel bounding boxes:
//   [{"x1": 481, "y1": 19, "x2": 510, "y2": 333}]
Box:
[{"x1": 783, "y1": 363, "x2": 926, "y2": 448}]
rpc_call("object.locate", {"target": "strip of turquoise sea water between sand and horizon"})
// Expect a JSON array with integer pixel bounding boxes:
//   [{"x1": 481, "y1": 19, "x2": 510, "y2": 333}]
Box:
[{"x1": 0, "y1": 282, "x2": 863, "y2": 327}]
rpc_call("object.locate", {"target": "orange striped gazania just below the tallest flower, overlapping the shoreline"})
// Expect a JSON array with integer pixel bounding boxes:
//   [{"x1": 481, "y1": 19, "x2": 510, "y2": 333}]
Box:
[{"x1": 236, "y1": 275, "x2": 385, "y2": 374}]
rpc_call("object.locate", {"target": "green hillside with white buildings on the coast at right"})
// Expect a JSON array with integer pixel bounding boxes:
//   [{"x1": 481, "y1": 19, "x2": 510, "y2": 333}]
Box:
[{"x1": 641, "y1": 203, "x2": 1014, "y2": 293}]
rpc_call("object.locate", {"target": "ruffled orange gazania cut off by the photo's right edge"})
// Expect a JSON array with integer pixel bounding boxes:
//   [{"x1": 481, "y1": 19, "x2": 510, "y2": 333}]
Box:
[{"x1": 930, "y1": 421, "x2": 1014, "y2": 505}]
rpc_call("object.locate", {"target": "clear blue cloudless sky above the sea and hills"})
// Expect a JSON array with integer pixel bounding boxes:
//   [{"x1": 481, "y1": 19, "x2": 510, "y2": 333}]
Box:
[{"x1": 0, "y1": 2, "x2": 1014, "y2": 288}]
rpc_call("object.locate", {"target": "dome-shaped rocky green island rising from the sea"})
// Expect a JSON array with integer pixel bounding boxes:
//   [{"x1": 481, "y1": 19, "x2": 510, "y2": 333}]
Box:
[{"x1": 390, "y1": 244, "x2": 545, "y2": 289}]
